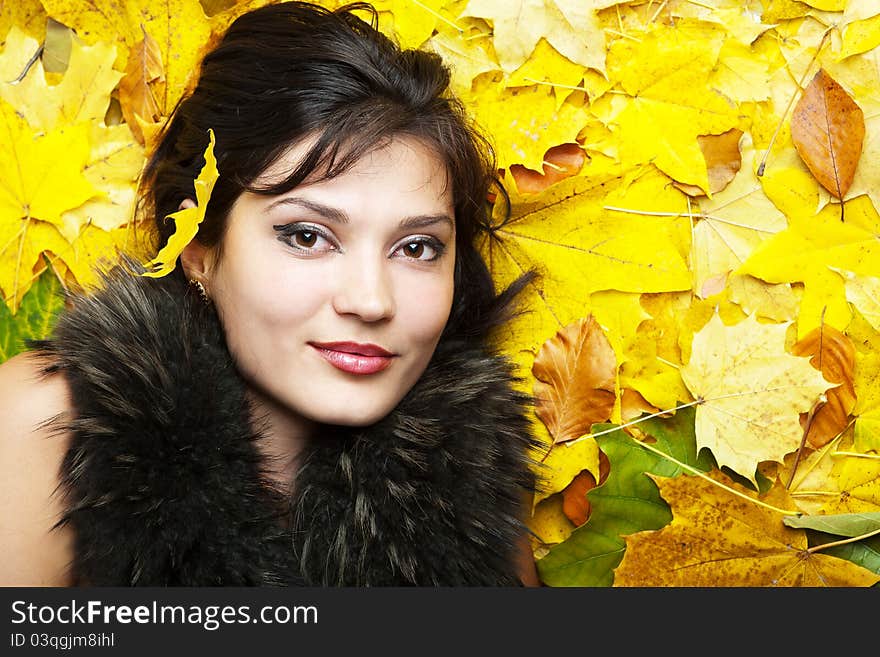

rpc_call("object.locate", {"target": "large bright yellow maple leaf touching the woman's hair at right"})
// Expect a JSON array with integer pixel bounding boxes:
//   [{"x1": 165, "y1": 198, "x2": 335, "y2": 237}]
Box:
[{"x1": 478, "y1": 168, "x2": 691, "y2": 390}]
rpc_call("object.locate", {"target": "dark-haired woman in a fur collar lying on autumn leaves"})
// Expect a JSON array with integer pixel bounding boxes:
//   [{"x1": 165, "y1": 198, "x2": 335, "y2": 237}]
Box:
[{"x1": 0, "y1": 2, "x2": 537, "y2": 586}]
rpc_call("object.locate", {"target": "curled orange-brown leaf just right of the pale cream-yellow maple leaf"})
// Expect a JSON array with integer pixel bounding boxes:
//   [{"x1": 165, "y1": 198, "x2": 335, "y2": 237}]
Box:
[{"x1": 791, "y1": 324, "x2": 856, "y2": 448}]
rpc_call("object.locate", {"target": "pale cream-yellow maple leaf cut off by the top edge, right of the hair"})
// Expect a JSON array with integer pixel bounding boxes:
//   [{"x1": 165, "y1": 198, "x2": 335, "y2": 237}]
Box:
[{"x1": 461, "y1": 0, "x2": 619, "y2": 73}]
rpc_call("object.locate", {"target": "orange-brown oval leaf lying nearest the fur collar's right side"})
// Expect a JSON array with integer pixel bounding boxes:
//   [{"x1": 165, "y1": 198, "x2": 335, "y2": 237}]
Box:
[{"x1": 532, "y1": 315, "x2": 617, "y2": 443}]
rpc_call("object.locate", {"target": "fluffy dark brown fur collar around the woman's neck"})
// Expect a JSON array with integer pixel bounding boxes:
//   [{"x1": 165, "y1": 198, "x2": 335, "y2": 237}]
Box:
[{"x1": 34, "y1": 270, "x2": 534, "y2": 586}]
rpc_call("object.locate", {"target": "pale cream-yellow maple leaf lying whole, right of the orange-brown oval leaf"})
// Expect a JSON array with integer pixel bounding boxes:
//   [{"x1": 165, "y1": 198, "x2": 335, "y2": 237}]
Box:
[{"x1": 681, "y1": 314, "x2": 832, "y2": 482}]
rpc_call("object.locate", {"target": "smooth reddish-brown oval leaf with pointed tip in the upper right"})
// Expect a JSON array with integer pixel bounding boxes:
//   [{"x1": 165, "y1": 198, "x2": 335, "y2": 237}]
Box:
[{"x1": 791, "y1": 69, "x2": 865, "y2": 199}]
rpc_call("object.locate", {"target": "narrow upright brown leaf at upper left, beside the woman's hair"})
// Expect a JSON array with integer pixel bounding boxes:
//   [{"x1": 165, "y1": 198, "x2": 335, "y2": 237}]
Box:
[{"x1": 119, "y1": 30, "x2": 165, "y2": 145}]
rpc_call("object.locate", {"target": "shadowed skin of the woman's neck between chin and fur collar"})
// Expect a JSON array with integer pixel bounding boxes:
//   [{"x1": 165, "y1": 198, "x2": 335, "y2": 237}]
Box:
[{"x1": 248, "y1": 388, "x2": 316, "y2": 493}]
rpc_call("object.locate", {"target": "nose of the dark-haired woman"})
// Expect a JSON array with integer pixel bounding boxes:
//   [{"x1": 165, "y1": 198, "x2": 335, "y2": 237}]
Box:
[{"x1": 333, "y1": 253, "x2": 395, "y2": 322}]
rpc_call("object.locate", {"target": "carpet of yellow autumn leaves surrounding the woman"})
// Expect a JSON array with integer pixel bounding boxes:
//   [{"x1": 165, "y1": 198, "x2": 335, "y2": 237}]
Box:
[{"x1": 0, "y1": 0, "x2": 880, "y2": 586}]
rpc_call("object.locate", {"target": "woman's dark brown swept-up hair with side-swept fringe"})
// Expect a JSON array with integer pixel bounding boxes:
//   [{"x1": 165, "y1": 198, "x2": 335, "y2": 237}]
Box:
[{"x1": 141, "y1": 2, "x2": 533, "y2": 339}]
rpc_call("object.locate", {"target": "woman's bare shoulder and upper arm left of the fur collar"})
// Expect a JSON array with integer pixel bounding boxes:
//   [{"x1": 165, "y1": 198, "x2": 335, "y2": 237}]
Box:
[{"x1": 0, "y1": 352, "x2": 73, "y2": 586}]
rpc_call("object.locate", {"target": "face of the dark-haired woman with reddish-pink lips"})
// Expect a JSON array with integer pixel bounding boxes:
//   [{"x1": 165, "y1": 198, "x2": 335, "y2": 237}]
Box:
[{"x1": 195, "y1": 138, "x2": 455, "y2": 425}]
